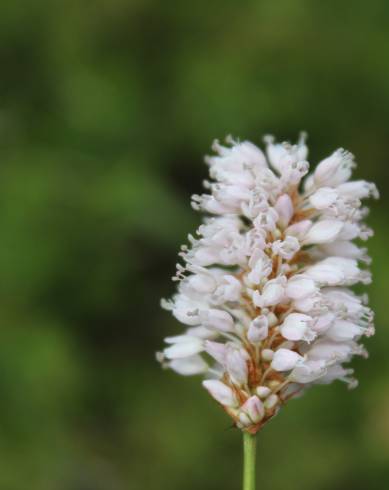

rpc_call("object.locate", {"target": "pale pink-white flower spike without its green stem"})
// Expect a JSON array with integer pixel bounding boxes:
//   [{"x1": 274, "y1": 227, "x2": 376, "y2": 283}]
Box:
[{"x1": 157, "y1": 135, "x2": 378, "y2": 433}]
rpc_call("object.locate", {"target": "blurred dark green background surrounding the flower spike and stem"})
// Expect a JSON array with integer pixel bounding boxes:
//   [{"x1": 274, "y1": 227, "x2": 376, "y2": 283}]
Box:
[{"x1": 0, "y1": 0, "x2": 389, "y2": 490}]
